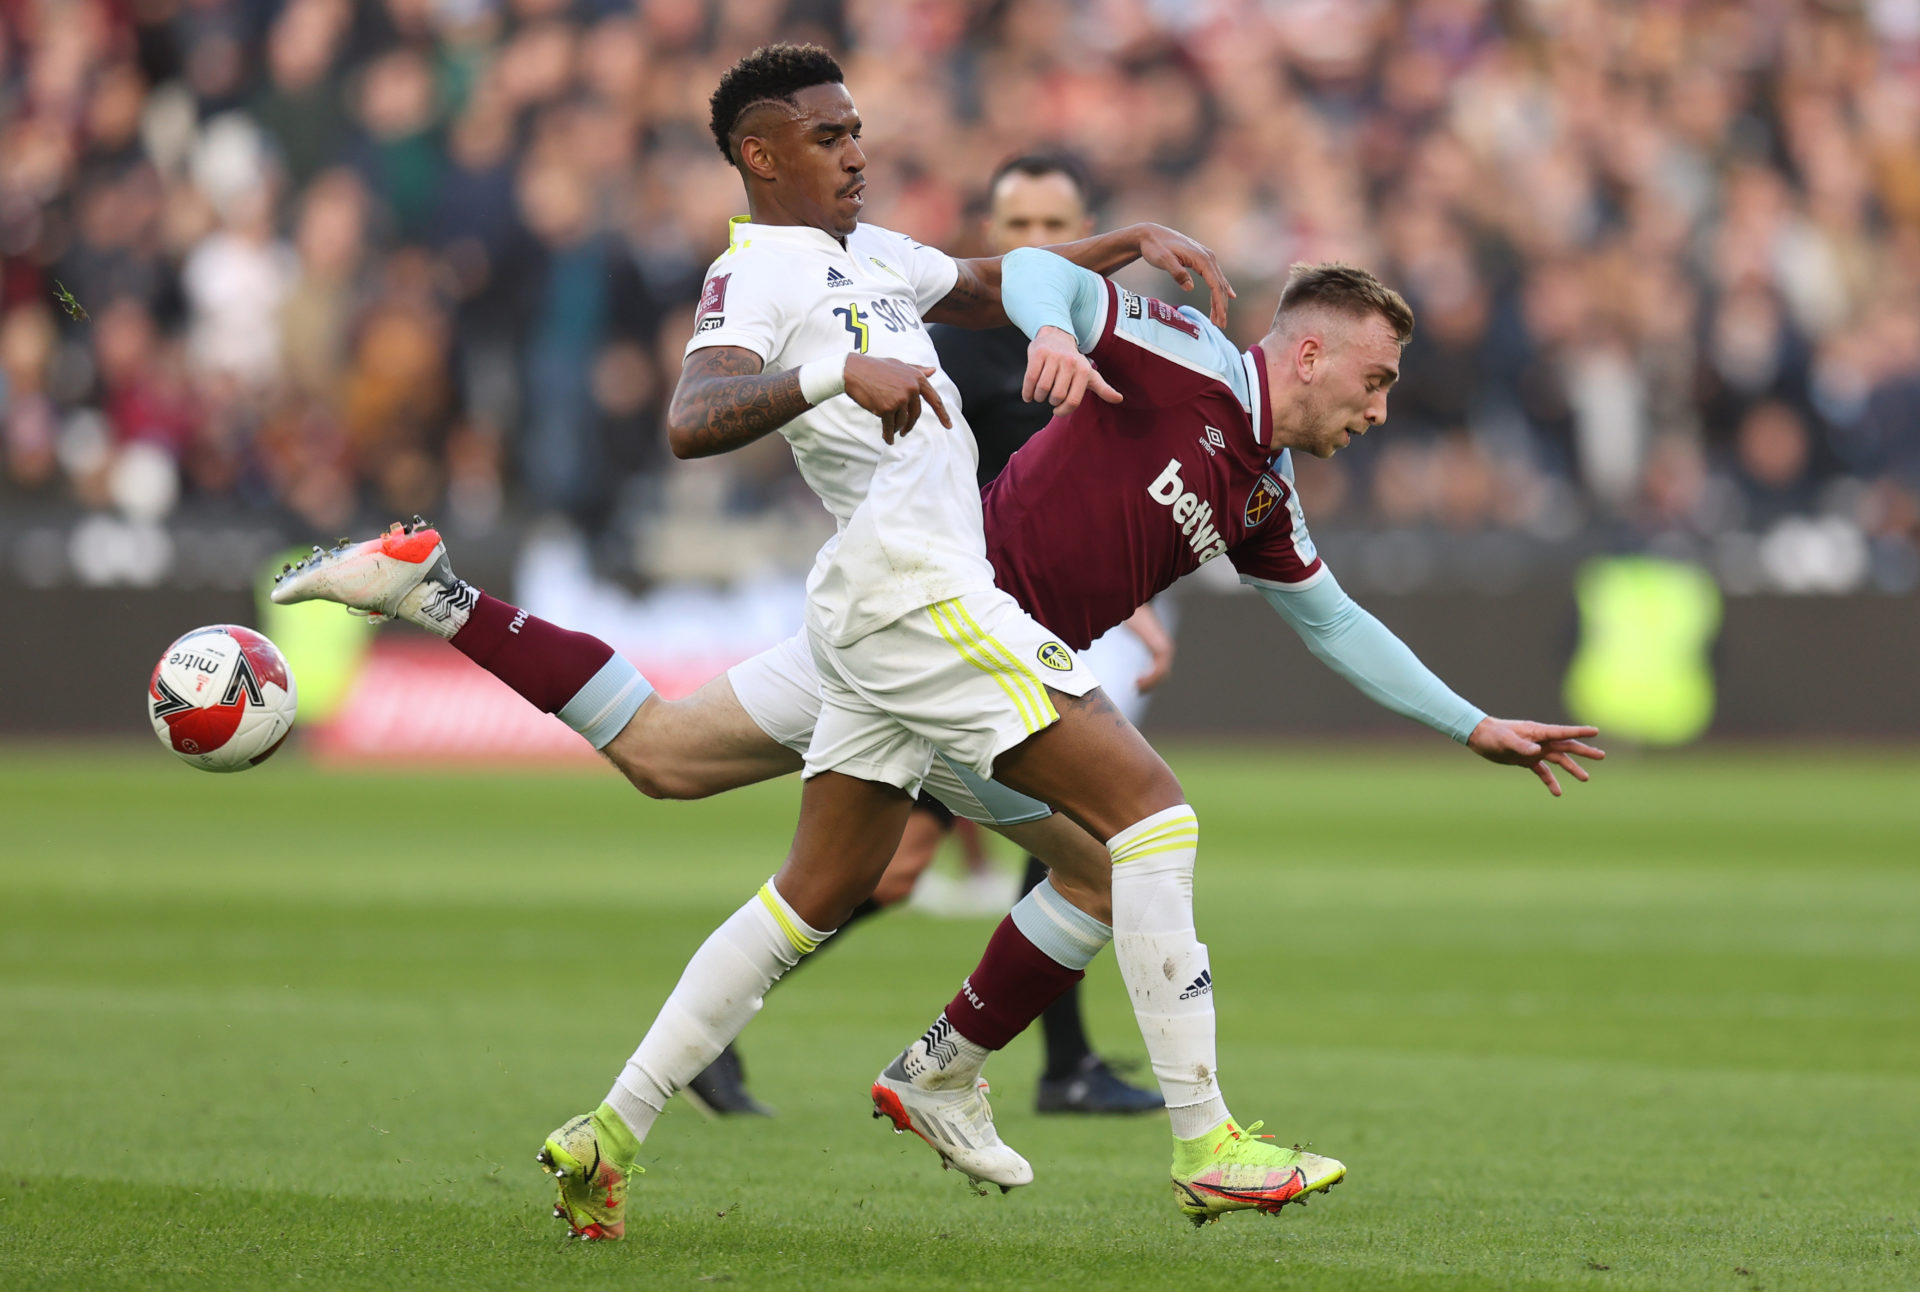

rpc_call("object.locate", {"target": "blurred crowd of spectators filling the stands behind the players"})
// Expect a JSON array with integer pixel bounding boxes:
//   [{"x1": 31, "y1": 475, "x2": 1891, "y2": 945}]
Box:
[{"x1": 0, "y1": 0, "x2": 1920, "y2": 589}]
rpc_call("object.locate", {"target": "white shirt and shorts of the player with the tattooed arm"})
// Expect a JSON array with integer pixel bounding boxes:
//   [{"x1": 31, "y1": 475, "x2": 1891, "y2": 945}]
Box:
[{"x1": 687, "y1": 219, "x2": 1098, "y2": 793}]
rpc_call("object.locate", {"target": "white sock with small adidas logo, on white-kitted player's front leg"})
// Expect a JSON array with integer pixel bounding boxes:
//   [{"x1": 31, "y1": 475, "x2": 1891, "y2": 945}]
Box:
[{"x1": 1106, "y1": 804, "x2": 1227, "y2": 1140}]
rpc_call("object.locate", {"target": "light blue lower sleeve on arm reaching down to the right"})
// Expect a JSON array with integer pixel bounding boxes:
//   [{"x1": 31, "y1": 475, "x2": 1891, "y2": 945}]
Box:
[{"x1": 1256, "y1": 566, "x2": 1486, "y2": 745}]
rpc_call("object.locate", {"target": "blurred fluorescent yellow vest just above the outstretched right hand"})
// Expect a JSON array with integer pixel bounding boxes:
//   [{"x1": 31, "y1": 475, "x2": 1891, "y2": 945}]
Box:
[{"x1": 1565, "y1": 557, "x2": 1720, "y2": 745}]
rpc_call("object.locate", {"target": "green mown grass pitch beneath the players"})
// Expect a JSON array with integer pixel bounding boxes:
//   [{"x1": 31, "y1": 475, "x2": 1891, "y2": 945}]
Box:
[{"x1": 0, "y1": 747, "x2": 1920, "y2": 1290}]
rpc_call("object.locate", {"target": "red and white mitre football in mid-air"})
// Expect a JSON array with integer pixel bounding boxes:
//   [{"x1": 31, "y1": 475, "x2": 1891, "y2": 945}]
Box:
[{"x1": 146, "y1": 624, "x2": 298, "y2": 772}]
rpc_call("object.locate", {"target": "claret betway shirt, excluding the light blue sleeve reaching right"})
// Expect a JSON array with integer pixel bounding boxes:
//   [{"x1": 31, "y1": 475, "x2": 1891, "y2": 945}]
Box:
[{"x1": 985, "y1": 251, "x2": 1325, "y2": 649}]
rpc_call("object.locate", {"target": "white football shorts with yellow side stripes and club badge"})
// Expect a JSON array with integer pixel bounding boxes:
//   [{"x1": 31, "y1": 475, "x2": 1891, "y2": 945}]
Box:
[{"x1": 804, "y1": 587, "x2": 1100, "y2": 793}]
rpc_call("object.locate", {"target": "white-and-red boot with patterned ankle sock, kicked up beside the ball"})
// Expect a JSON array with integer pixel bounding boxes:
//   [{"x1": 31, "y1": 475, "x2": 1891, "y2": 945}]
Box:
[{"x1": 271, "y1": 516, "x2": 480, "y2": 637}]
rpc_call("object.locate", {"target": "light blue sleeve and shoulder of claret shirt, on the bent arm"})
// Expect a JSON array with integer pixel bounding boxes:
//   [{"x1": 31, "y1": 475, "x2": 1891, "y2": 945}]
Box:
[{"x1": 1000, "y1": 248, "x2": 1254, "y2": 407}]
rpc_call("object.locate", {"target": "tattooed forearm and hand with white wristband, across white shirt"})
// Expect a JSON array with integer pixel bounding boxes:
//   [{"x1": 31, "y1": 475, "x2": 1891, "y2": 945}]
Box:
[{"x1": 666, "y1": 346, "x2": 952, "y2": 457}]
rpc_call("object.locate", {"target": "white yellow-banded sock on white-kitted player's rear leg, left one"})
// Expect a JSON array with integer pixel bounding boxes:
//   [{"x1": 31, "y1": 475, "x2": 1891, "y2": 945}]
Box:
[{"x1": 607, "y1": 879, "x2": 829, "y2": 1140}]
